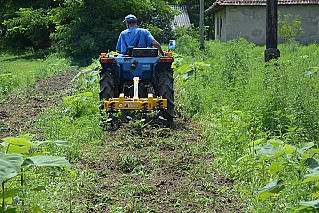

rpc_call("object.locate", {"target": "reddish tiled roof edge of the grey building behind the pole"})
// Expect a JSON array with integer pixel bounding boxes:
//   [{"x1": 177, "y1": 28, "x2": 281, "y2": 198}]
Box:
[{"x1": 205, "y1": 0, "x2": 319, "y2": 13}]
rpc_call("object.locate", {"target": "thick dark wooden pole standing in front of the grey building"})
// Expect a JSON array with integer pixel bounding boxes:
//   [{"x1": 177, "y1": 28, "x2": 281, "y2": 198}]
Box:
[{"x1": 265, "y1": 0, "x2": 280, "y2": 62}]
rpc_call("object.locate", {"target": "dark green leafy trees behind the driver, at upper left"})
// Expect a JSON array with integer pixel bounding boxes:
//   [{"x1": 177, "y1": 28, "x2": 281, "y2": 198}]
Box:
[{"x1": 0, "y1": 0, "x2": 172, "y2": 65}]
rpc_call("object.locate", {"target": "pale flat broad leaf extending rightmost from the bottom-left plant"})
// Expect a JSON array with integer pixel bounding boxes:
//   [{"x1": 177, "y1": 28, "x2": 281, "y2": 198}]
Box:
[{"x1": 23, "y1": 155, "x2": 72, "y2": 169}]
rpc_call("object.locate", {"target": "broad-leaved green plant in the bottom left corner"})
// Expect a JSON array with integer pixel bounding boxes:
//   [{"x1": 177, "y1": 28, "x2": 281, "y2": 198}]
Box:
[{"x1": 0, "y1": 134, "x2": 71, "y2": 212}]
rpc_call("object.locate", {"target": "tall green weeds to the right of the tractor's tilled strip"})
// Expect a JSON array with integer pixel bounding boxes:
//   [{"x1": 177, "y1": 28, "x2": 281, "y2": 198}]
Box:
[{"x1": 175, "y1": 38, "x2": 319, "y2": 212}]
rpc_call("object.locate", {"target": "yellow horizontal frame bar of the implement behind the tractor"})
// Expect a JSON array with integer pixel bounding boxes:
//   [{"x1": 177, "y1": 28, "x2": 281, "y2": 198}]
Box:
[{"x1": 104, "y1": 93, "x2": 167, "y2": 110}]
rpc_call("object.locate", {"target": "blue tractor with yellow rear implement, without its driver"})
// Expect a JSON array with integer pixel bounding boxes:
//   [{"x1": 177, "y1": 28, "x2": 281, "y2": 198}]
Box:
[{"x1": 99, "y1": 47, "x2": 174, "y2": 131}]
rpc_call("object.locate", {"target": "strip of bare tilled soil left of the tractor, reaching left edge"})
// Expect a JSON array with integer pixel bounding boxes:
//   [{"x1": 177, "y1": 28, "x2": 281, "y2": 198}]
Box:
[{"x1": 0, "y1": 71, "x2": 76, "y2": 139}]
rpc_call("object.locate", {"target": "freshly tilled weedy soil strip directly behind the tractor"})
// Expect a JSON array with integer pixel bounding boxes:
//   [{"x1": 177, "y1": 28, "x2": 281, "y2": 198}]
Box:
[{"x1": 81, "y1": 117, "x2": 243, "y2": 213}]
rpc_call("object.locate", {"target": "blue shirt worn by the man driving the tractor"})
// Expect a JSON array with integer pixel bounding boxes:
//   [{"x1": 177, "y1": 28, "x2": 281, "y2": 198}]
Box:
[{"x1": 116, "y1": 27, "x2": 155, "y2": 54}]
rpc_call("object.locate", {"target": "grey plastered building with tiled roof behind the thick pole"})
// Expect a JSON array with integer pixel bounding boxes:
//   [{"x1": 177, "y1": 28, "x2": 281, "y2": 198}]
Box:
[{"x1": 205, "y1": 0, "x2": 319, "y2": 44}]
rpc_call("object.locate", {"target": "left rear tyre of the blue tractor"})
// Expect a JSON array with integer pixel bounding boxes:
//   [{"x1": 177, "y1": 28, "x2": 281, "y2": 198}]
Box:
[{"x1": 99, "y1": 69, "x2": 115, "y2": 109}]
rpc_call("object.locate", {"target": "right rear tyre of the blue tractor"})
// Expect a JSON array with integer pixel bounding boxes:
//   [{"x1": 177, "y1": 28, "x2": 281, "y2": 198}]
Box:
[{"x1": 156, "y1": 68, "x2": 174, "y2": 127}]
